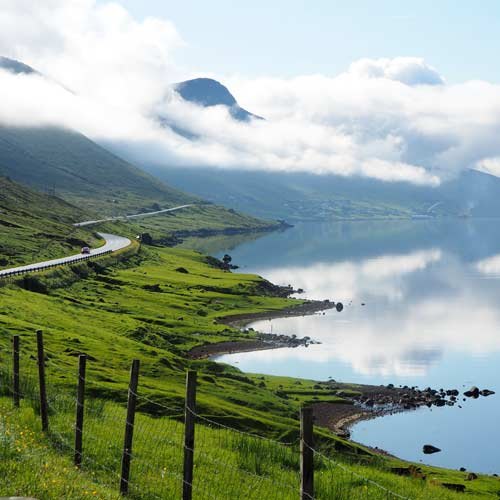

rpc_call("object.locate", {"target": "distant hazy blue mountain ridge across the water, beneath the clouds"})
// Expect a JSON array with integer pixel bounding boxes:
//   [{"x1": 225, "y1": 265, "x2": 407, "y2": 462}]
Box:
[{"x1": 146, "y1": 166, "x2": 500, "y2": 220}]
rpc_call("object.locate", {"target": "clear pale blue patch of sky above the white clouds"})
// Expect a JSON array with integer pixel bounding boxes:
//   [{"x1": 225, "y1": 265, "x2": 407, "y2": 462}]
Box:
[{"x1": 101, "y1": 0, "x2": 500, "y2": 83}]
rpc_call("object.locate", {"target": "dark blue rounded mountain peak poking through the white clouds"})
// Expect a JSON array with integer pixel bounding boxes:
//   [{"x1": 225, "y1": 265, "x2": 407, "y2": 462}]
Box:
[{"x1": 174, "y1": 78, "x2": 263, "y2": 122}]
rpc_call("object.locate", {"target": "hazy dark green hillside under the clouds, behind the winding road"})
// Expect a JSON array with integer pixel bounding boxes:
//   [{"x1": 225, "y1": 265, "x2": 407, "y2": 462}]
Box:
[{"x1": 0, "y1": 126, "x2": 195, "y2": 215}]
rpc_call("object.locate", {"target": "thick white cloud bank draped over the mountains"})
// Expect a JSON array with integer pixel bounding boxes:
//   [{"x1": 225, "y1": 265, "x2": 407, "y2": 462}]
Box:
[{"x1": 0, "y1": 0, "x2": 500, "y2": 186}]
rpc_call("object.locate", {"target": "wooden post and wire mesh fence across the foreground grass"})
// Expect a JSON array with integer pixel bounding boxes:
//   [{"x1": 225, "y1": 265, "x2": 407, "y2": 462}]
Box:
[{"x1": 0, "y1": 331, "x2": 407, "y2": 500}]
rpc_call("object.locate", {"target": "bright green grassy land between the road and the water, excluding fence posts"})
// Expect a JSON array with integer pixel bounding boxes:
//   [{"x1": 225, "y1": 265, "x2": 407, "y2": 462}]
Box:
[{"x1": 0, "y1": 248, "x2": 500, "y2": 499}]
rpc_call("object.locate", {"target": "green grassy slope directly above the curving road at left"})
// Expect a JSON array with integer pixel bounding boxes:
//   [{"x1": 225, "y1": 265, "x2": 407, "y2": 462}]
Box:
[{"x1": 0, "y1": 177, "x2": 100, "y2": 268}]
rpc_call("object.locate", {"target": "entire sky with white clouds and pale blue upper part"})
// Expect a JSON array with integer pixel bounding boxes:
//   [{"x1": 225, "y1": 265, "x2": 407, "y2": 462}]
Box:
[{"x1": 0, "y1": 0, "x2": 500, "y2": 187}]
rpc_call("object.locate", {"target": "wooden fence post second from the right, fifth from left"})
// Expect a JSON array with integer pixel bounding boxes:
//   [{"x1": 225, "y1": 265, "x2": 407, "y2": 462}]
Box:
[{"x1": 182, "y1": 370, "x2": 196, "y2": 500}]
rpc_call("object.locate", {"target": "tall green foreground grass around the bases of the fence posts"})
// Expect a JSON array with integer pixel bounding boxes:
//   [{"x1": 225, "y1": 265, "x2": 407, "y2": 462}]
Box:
[{"x1": 0, "y1": 390, "x2": 499, "y2": 500}]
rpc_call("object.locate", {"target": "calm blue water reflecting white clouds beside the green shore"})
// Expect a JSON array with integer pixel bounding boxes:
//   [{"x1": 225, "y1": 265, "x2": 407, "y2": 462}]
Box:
[{"x1": 202, "y1": 219, "x2": 500, "y2": 473}]
